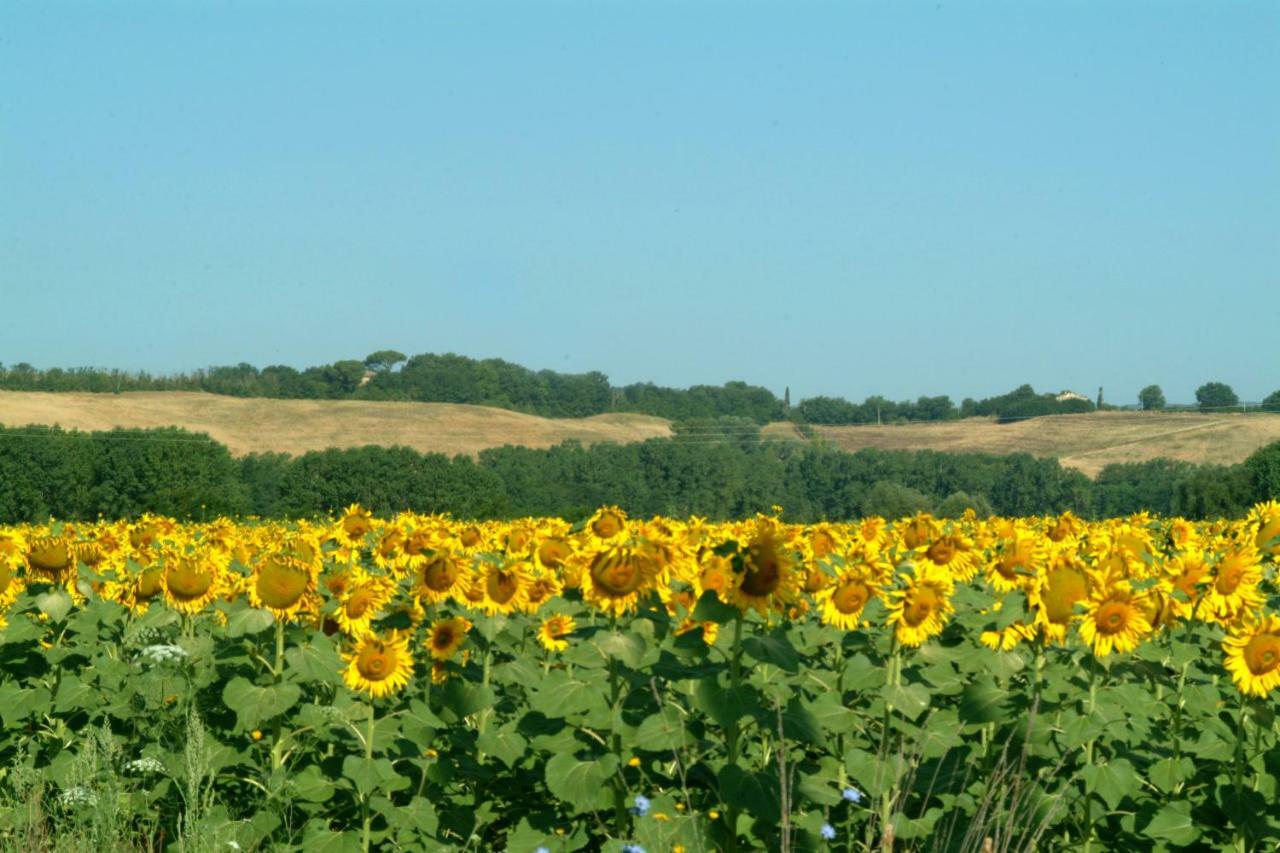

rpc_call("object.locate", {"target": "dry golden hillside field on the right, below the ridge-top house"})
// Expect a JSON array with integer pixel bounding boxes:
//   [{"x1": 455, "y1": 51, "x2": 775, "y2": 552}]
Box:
[{"x1": 765, "y1": 411, "x2": 1280, "y2": 476}]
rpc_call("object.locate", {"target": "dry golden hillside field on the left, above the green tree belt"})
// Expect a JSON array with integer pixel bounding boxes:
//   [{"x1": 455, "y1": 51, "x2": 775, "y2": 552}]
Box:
[{"x1": 0, "y1": 391, "x2": 671, "y2": 456}]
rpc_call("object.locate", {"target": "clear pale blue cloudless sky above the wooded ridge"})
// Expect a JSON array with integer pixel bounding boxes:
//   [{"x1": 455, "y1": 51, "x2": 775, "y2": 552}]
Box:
[{"x1": 0, "y1": 0, "x2": 1280, "y2": 402}]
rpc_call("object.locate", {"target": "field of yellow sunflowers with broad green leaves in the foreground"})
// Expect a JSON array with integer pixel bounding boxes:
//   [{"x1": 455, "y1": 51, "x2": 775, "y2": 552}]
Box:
[{"x1": 0, "y1": 502, "x2": 1280, "y2": 853}]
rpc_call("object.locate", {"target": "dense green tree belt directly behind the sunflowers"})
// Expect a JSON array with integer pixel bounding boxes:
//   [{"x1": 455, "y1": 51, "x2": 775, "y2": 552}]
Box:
[{"x1": 0, "y1": 427, "x2": 1280, "y2": 523}]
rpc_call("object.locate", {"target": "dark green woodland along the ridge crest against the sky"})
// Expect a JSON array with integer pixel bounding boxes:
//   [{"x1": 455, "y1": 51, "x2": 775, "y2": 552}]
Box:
[{"x1": 0, "y1": 350, "x2": 1208, "y2": 424}]
